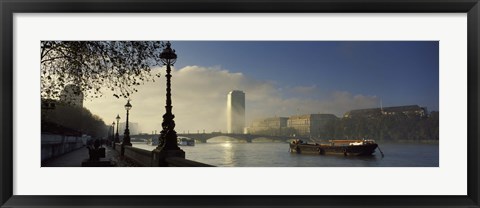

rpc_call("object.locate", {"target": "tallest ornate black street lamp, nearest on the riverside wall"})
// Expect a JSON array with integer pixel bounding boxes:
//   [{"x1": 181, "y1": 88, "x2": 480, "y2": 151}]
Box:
[{"x1": 157, "y1": 42, "x2": 180, "y2": 151}]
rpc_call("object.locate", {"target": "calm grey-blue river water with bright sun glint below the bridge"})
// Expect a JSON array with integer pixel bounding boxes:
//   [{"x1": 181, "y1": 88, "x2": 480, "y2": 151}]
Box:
[{"x1": 133, "y1": 140, "x2": 439, "y2": 167}]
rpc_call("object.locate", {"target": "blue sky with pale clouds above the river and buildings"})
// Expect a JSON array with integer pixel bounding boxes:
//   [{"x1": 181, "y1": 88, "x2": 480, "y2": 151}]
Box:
[{"x1": 84, "y1": 41, "x2": 439, "y2": 133}]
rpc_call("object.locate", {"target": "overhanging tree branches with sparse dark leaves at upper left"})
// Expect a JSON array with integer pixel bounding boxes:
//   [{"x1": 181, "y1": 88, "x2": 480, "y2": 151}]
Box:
[{"x1": 40, "y1": 41, "x2": 164, "y2": 99}]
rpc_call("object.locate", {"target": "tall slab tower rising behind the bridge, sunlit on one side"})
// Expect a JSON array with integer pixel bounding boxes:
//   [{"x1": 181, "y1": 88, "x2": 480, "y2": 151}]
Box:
[{"x1": 227, "y1": 90, "x2": 245, "y2": 134}]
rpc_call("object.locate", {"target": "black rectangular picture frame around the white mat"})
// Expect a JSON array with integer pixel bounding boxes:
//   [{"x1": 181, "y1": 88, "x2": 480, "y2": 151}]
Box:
[{"x1": 0, "y1": 0, "x2": 480, "y2": 207}]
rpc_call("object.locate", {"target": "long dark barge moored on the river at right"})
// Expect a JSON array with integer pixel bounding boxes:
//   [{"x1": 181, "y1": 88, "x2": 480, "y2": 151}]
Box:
[{"x1": 290, "y1": 139, "x2": 383, "y2": 156}]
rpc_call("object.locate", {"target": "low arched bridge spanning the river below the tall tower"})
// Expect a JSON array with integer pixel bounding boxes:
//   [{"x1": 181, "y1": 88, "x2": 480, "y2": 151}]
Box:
[{"x1": 130, "y1": 133, "x2": 308, "y2": 143}]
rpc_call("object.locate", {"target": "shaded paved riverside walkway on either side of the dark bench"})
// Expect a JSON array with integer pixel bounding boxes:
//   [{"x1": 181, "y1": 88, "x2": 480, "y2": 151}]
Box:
[{"x1": 42, "y1": 146, "x2": 137, "y2": 167}]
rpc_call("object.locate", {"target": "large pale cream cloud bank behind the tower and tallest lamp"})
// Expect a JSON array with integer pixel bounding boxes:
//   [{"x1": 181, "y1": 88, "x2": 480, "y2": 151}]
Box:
[{"x1": 84, "y1": 66, "x2": 378, "y2": 133}]
